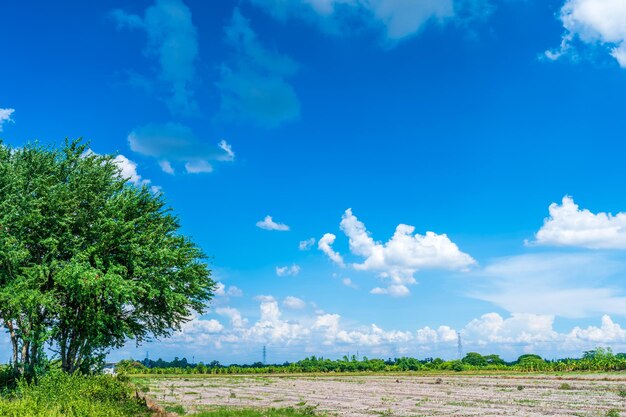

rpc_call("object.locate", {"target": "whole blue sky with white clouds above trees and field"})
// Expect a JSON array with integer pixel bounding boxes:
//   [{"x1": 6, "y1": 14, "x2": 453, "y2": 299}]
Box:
[{"x1": 0, "y1": 0, "x2": 626, "y2": 363}]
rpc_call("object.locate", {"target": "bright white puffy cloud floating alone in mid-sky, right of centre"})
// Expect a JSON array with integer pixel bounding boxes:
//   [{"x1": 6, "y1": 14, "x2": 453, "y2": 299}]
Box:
[{"x1": 318, "y1": 209, "x2": 476, "y2": 297}]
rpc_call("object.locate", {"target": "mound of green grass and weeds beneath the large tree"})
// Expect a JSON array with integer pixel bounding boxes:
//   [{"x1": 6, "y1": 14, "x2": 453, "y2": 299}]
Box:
[{"x1": 0, "y1": 372, "x2": 149, "y2": 417}]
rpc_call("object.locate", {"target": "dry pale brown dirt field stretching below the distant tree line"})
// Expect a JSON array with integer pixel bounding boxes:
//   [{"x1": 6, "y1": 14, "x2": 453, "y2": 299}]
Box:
[{"x1": 139, "y1": 373, "x2": 626, "y2": 416}]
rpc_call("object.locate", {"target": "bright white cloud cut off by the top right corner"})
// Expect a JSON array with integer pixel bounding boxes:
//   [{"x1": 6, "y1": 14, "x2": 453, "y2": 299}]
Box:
[{"x1": 546, "y1": 0, "x2": 626, "y2": 68}]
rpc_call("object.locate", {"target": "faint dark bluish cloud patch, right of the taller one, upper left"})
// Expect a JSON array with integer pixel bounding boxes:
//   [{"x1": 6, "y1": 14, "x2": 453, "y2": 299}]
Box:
[{"x1": 217, "y1": 9, "x2": 300, "y2": 128}]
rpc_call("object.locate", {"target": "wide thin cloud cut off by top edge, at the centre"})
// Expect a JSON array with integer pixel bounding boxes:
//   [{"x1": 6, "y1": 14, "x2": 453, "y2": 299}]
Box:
[{"x1": 250, "y1": 0, "x2": 493, "y2": 43}]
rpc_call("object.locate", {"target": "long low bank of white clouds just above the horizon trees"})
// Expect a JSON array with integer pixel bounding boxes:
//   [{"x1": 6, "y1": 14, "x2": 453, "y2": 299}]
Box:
[{"x1": 165, "y1": 296, "x2": 626, "y2": 358}]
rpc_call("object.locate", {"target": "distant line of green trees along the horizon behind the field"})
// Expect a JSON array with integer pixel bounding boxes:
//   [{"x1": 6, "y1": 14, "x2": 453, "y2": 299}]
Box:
[{"x1": 117, "y1": 348, "x2": 626, "y2": 374}]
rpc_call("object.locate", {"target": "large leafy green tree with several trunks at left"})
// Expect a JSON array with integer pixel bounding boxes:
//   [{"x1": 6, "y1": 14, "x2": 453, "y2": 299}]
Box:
[{"x1": 0, "y1": 140, "x2": 214, "y2": 373}]
